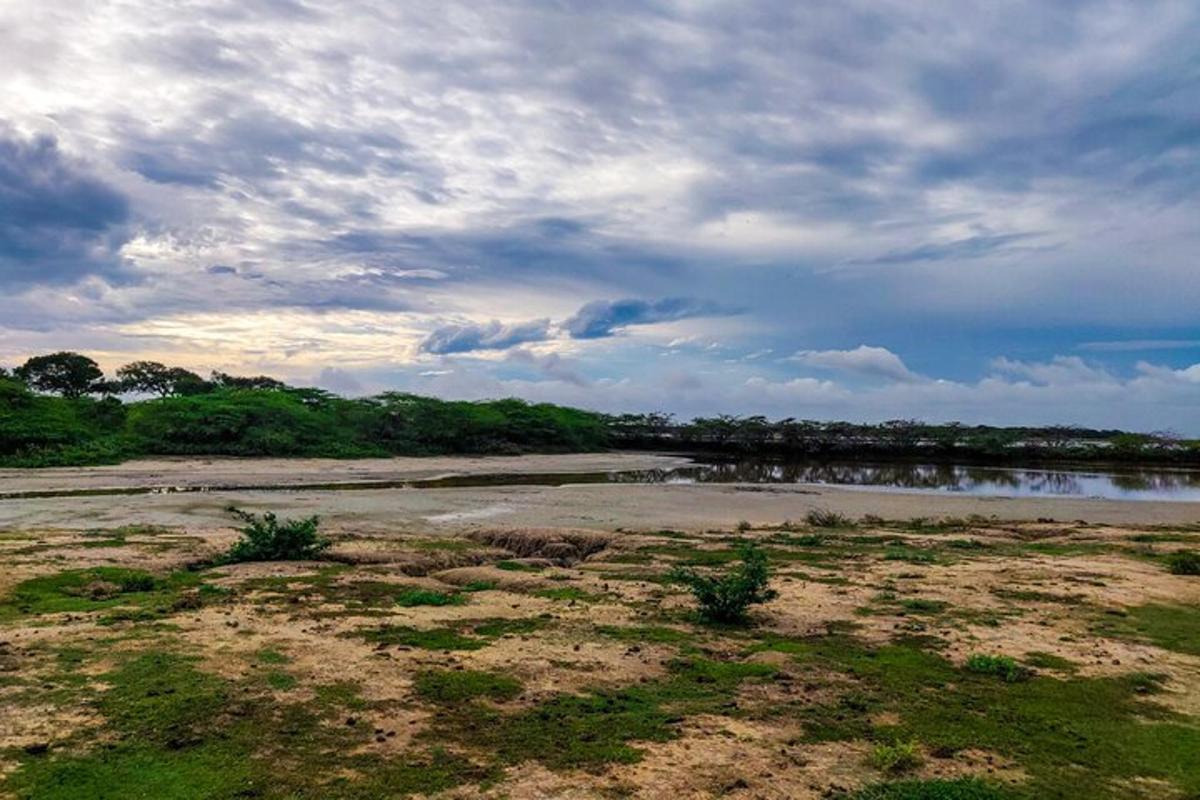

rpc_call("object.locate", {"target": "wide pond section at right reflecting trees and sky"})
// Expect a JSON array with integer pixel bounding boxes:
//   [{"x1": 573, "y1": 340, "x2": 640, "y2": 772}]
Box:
[{"x1": 607, "y1": 461, "x2": 1200, "y2": 501}]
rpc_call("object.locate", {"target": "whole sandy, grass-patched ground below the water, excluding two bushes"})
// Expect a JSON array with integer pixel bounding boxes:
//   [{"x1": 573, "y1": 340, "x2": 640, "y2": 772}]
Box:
[{"x1": 0, "y1": 455, "x2": 1200, "y2": 800}]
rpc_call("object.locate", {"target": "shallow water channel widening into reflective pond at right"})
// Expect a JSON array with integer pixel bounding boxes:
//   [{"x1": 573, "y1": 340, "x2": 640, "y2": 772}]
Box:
[{"x1": 7, "y1": 459, "x2": 1200, "y2": 503}]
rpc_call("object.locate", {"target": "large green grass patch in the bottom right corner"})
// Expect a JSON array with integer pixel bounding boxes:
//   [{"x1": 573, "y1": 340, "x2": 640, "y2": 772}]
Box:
[{"x1": 756, "y1": 634, "x2": 1200, "y2": 800}]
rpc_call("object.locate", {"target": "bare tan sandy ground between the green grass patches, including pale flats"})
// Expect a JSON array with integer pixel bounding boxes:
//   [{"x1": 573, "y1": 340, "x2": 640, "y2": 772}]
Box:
[{"x1": 0, "y1": 453, "x2": 1200, "y2": 800}]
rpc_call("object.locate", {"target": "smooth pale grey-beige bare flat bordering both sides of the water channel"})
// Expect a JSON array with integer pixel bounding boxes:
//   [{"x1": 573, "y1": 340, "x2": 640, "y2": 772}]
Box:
[{"x1": 0, "y1": 453, "x2": 1200, "y2": 533}]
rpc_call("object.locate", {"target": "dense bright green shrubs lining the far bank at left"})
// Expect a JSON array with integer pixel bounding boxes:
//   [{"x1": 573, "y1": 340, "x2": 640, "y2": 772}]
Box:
[{"x1": 0, "y1": 378, "x2": 607, "y2": 467}]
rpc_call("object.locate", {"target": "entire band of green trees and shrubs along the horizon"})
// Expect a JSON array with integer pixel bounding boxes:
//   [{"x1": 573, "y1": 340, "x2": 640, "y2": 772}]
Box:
[{"x1": 0, "y1": 353, "x2": 1200, "y2": 467}]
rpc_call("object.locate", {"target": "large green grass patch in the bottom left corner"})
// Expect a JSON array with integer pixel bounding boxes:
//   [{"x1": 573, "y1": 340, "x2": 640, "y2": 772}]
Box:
[{"x1": 2, "y1": 651, "x2": 493, "y2": 800}]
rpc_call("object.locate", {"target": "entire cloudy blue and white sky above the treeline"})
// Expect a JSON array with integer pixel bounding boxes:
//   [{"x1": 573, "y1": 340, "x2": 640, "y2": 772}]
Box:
[{"x1": 0, "y1": 0, "x2": 1200, "y2": 435}]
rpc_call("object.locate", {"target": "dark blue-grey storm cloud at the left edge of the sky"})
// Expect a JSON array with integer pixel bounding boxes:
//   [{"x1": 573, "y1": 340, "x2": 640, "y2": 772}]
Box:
[{"x1": 0, "y1": 132, "x2": 130, "y2": 287}]
